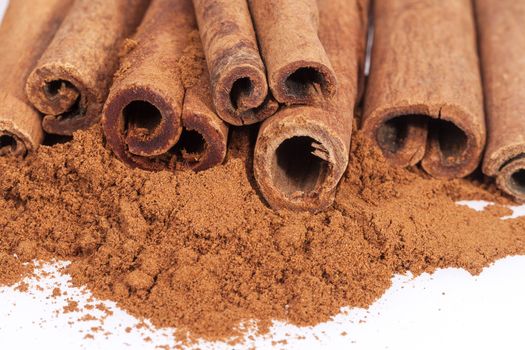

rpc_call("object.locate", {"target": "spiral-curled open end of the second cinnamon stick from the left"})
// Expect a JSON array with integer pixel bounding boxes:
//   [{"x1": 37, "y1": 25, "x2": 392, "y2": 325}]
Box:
[{"x1": 26, "y1": 63, "x2": 97, "y2": 135}]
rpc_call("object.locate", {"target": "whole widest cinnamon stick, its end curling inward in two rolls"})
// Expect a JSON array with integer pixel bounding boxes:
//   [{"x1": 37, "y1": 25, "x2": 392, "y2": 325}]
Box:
[{"x1": 362, "y1": 0, "x2": 485, "y2": 178}]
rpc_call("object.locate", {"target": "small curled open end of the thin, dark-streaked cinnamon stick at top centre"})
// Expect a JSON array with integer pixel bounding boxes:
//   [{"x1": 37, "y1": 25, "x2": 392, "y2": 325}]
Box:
[{"x1": 212, "y1": 64, "x2": 279, "y2": 126}]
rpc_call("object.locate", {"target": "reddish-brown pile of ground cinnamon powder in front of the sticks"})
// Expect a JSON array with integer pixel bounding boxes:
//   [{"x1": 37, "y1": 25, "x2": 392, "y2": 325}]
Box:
[{"x1": 0, "y1": 127, "x2": 525, "y2": 339}]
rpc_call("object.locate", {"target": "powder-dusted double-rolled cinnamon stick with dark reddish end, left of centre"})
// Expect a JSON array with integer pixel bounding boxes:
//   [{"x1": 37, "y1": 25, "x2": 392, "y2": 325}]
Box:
[{"x1": 102, "y1": 0, "x2": 227, "y2": 170}]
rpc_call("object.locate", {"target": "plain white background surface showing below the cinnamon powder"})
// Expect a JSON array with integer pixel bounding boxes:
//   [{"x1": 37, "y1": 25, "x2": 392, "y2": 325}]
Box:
[{"x1": 0, "y1": 0, "x2": 525, "y2": 350}]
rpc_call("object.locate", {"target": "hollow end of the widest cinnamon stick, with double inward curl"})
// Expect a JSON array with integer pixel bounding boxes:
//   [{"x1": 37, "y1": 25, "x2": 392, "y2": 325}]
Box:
[{"x1": 362, "y1": 105, "x2": 485, "y2": 179}]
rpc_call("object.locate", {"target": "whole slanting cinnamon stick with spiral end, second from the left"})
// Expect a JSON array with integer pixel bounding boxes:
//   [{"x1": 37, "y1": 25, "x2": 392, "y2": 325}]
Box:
[{"x1": 26, "y1": 0, "x2": 149, "y2": 135}]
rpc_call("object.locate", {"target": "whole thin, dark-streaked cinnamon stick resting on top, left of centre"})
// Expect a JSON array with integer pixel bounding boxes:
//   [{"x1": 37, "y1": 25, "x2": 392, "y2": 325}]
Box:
[{"x1": 193, "y1": 0, "x2": 279, "y2": 125}]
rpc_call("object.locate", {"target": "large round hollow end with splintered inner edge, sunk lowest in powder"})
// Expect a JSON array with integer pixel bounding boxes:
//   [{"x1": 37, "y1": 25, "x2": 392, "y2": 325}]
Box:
[{"x1": 254, "y1": 106, "x2": 348, "y2": 212}]
